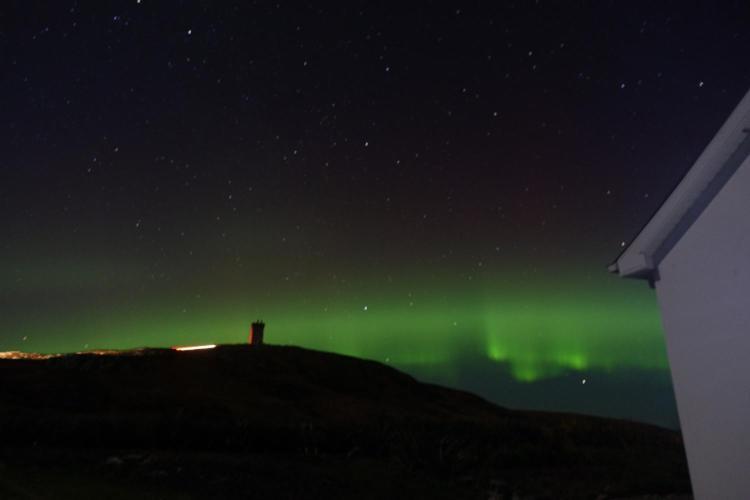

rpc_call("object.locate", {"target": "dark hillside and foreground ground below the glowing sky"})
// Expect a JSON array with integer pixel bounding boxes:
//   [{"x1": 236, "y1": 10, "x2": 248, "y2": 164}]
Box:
[{"x1": 0, "y1": 346, "x2": 690, "y2": 499}]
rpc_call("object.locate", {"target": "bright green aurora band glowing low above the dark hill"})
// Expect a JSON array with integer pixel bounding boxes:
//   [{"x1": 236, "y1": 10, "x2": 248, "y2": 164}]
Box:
[{"x1": 0, "y1": 273, "x2": 668, "y2": 382}]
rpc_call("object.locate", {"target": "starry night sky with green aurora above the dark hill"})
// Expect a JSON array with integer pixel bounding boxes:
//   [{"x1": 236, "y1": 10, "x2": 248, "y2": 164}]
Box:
[{"x1": 0, "y1": 0, "x2": 750, "y2": 425}]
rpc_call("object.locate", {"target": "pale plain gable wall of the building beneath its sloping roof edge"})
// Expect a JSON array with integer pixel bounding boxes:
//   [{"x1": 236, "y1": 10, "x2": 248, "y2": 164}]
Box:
[{"x1": 656, "y1": 154, "x2": 750, "y2": 500}]
